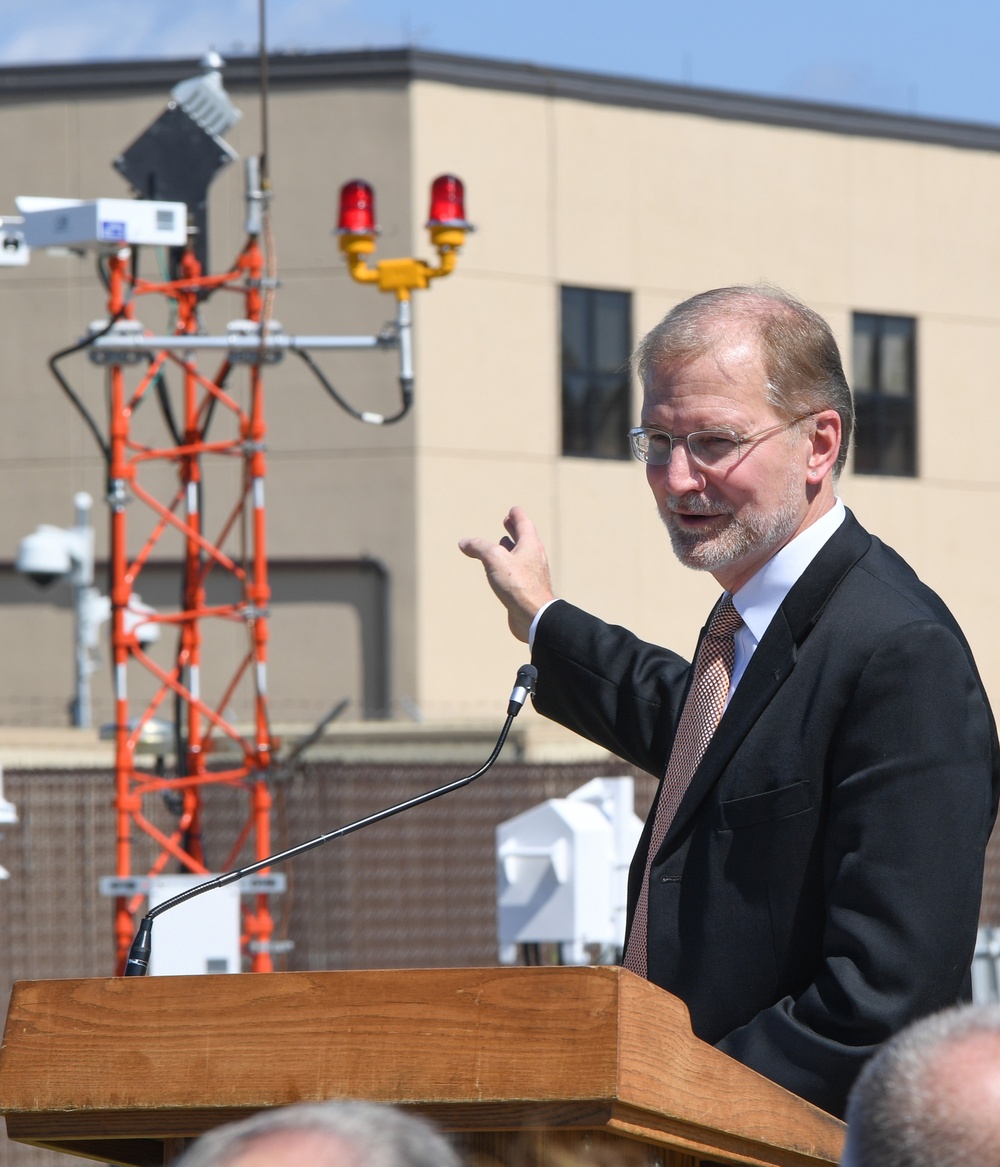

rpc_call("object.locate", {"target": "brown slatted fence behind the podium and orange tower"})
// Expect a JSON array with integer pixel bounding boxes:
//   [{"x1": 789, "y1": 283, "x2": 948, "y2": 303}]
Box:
[{"x1": 0, "y1": 762, "x2": 655, "y2": 1167}]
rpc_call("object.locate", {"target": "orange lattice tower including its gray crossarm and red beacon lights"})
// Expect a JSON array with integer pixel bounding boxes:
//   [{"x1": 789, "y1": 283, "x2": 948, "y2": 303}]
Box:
[{"x1": 61, "y1": 167, "x2": 470, "y2": 972}]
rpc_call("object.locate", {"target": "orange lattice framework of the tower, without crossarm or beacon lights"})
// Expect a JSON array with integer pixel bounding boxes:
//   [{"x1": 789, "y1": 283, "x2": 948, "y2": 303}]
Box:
[{"x1": 103, "y1": 236, "x2": 274, "y2": 972}]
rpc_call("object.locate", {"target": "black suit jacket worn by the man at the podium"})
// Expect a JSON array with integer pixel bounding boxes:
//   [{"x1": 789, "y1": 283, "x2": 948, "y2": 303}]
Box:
[{"x1": 532, "y1": 512, "x2": 998, "y2": 1114}]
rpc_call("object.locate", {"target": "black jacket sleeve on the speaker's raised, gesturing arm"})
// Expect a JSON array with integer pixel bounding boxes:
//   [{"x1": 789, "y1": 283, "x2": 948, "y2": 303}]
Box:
[{"x1": 531, "y1": 600, "x2": 691, "y2": 777}]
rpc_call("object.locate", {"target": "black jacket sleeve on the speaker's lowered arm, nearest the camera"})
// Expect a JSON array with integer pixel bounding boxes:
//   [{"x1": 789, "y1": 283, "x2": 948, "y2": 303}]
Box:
[{"x1": 718, "y1": 621, "x2": 996, "y2": 1113}]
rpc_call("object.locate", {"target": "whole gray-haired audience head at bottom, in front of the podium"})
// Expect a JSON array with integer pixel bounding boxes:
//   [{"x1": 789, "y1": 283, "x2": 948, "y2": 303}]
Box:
[{"x1": 175, "y1": 1102, "x2": 460, "y2": 1167}]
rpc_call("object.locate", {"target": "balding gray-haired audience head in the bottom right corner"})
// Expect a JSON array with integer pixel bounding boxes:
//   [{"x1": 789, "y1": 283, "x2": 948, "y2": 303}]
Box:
[{"x1": 840, "y1": 1004, "x2": 1000, "y2": 1167}]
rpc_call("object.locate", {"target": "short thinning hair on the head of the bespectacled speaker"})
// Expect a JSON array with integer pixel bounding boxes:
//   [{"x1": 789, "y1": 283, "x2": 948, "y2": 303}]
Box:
[{"x1": 632, "y1": 284, "x2": 854, "y2": 475}]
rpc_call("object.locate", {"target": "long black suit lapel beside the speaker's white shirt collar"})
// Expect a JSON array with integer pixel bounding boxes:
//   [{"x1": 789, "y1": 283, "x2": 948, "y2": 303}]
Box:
[{"x1": 664, "y1": 511, "x2": 872, "y2": 846}]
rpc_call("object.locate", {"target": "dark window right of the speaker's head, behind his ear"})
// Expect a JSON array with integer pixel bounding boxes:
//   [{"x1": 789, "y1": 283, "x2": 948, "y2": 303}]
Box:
[{"x1": 853, "y1": 312, "x2": 917, "y2": 477}]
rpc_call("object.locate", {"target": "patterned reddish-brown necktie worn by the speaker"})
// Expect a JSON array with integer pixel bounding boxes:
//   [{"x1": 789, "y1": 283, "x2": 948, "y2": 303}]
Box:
[{"x1": 622, "y1": 592, "x2": 743, "y2": 977}]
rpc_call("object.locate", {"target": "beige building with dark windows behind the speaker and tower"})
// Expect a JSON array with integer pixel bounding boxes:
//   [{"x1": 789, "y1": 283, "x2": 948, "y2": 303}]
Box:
[{"x1": 0, "y1": 50, "x2": 1000, "y2": 725}]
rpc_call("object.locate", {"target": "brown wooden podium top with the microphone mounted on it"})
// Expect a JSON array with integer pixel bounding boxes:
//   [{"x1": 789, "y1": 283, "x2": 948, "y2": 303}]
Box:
[{"x1": 0, "y1": 967, "x2": 844, "y2": 1167}]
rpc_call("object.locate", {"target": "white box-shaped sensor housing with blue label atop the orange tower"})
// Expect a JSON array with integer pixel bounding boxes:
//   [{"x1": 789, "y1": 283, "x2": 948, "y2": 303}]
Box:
[{"x1": 15, "y1": 195, "x2": 188, "y2": 249}]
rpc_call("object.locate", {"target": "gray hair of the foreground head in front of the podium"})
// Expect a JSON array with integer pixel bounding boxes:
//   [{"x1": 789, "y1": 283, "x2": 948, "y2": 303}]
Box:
[{"x1": 175, "y1": 1102, "x2": 461, "y2": 1167}]
